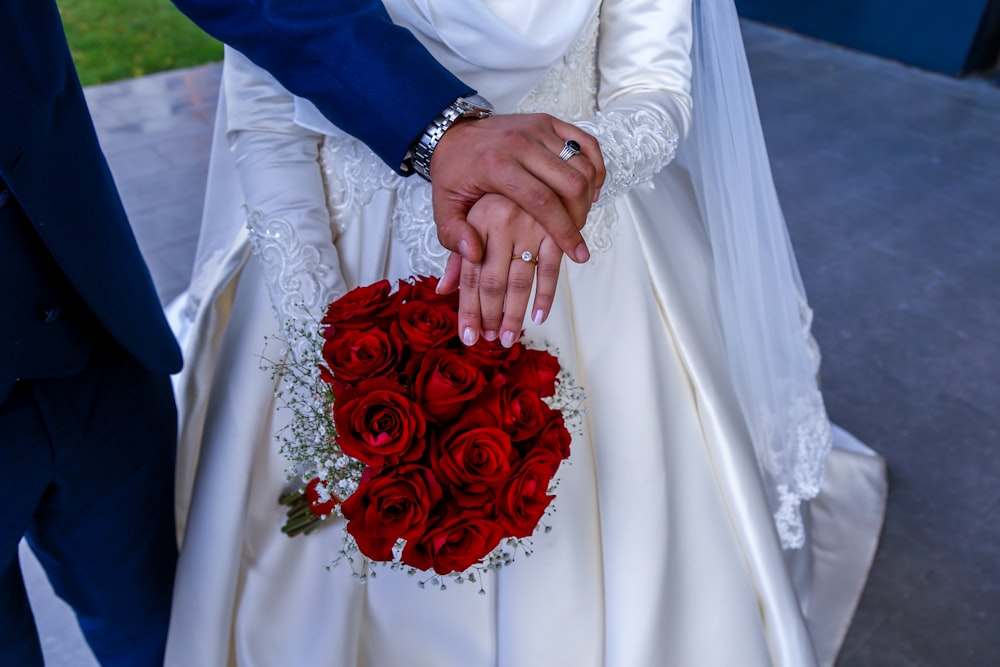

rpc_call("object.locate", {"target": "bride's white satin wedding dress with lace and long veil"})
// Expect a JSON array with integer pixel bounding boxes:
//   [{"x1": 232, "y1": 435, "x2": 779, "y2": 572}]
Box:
[{"x1": 167, "y1": 0, "x2": 885, "y2": 667}]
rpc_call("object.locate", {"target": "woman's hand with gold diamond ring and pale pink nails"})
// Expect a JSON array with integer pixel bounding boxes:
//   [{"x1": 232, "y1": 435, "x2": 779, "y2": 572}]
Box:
[{"x1": 438, "y1": 194, "x2": 563, "y2": 347}]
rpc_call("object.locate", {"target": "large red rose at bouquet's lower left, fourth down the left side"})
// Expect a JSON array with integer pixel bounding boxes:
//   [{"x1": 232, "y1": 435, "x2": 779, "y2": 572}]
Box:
[{"x1": 340, "y1": 465, "x2": 442, "y2": 561}]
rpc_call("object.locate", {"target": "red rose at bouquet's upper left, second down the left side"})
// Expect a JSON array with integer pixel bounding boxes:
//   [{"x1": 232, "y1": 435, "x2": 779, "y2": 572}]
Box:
[{"x1": 323, "y1": 327, "x2": 400, "y2": 393}]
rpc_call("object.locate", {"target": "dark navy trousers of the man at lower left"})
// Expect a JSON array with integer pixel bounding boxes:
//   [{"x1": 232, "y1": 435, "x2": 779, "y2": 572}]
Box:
[{"x1": 0, "y1": 334, "x2": 177, "y2": 667}]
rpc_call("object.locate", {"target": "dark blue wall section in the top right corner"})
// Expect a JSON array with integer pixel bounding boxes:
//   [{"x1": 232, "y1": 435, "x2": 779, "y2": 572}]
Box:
[{"x1": 736, "y1": 0, "x2": 987, "y2": 75}]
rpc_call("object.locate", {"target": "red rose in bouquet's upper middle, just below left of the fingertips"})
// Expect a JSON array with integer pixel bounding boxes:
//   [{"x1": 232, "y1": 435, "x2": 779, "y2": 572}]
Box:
[{"x1": 413, "y1": 348, "x2": 486, "y2": 423}]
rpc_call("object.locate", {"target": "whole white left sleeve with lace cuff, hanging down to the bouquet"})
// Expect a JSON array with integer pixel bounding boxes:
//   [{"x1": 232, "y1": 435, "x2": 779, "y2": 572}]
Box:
[{"x1": 224, "y1": 51, "x2": 346, "y2": 359}]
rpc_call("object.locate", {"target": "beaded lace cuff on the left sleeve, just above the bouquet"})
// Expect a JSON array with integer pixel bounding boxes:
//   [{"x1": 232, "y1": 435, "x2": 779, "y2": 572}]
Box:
[{"x1": 246, "y1": 210, "x2": 339, "y2": 359}]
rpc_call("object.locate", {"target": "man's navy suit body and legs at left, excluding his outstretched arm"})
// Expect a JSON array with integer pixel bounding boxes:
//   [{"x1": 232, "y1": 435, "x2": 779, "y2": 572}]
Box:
[{"x1": 0, "y1": 0, "x2": 181, "y2": 667}]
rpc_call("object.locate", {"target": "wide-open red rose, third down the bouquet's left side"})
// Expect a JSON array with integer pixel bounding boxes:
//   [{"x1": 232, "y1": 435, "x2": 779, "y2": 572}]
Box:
[{"x1": 333, "y1": 379, "x2": 427, "y2": 468}]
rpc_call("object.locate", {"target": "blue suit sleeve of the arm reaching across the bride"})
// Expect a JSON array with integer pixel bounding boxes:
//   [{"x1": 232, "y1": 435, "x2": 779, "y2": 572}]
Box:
[{"x1": 174, "y1": 0, "x2": 474, "y2": 171}]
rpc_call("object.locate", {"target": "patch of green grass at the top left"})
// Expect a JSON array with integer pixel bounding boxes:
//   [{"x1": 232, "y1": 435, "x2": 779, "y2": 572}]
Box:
[{"x1": 58, "y1": 0, "x2": 222, "y2": 86}]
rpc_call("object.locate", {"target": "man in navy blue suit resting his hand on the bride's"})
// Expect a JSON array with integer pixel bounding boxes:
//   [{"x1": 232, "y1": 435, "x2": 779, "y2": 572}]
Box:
[{"x1": 0, "y1": 0, "x2": 603, "y2": 667}]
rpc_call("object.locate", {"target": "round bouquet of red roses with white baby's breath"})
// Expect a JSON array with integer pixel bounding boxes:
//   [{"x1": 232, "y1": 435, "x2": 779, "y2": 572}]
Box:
[{"x1": 281, "y1": 277, "x2": 582, "y2": 583}]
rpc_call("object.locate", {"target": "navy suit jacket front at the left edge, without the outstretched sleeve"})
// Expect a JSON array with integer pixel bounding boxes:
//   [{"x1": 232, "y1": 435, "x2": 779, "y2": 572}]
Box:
[{"x1": 0, "y1": 0, "x2": 181, "y2": 384}]
